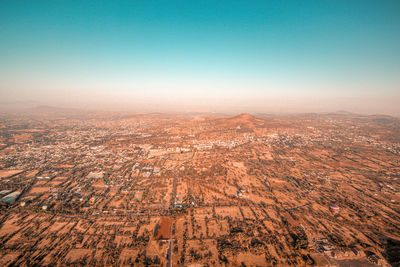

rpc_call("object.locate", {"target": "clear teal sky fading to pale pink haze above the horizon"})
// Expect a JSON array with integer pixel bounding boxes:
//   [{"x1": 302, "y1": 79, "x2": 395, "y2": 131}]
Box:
[{"x1": 0, "y1": 0, "x2": 400, "y2": 116}]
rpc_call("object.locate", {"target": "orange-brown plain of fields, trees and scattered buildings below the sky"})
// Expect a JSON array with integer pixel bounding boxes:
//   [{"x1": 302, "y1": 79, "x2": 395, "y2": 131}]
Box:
[{"x1": 0, "y1": 110, "x2": 400, "y2": 266}]
